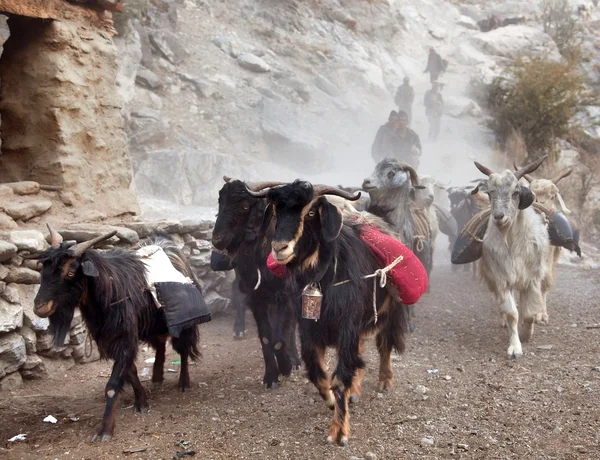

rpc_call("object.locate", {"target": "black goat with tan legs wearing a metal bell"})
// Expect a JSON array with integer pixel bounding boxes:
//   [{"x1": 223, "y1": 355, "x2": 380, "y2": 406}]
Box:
[{"x1": 249, "y1": 181, "x2": 406, "y2": 445}]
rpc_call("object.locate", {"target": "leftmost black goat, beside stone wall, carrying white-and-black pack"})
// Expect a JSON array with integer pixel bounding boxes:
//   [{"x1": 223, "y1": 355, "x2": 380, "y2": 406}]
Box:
[{"x1": 34, "y1": 225, "x2": 200, "y2": 441}]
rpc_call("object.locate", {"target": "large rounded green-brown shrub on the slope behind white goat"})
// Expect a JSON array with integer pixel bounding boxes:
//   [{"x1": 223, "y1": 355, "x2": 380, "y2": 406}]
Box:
[{"x1": 485, "y1": 57, "x2": 592, "y2": 157}]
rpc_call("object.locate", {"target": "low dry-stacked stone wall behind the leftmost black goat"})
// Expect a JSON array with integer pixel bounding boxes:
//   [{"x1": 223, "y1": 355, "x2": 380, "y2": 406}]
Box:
[{"x1": 0, "y1": 191, "x2": 233, "y2": 390}]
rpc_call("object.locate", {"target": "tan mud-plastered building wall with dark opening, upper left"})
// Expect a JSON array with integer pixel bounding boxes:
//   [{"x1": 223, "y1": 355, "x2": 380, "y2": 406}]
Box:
[{"x1": 0, "y1": 0, "x2": 138, "y2": 218}]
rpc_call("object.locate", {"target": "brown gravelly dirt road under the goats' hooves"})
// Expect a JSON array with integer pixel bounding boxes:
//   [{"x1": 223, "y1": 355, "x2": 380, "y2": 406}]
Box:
[{"x1": 0, "y1": 267, "x2": 600, "y2": 459}]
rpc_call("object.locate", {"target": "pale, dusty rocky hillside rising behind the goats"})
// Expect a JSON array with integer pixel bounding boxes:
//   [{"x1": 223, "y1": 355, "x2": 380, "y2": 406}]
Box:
[{"x1": 117, "y1": 0, "x2": 600, "y2": 235}]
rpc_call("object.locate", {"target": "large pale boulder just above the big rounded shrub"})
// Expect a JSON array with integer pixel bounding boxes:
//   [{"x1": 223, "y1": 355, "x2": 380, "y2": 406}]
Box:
[{"x1": 471, "y1": 25, "x2": 561, "y2": 60}]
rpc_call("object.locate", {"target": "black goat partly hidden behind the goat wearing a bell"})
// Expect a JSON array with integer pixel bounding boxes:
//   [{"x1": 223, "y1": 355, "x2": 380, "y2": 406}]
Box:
[{"x1": 212, "y1": 178, "x2": 300, "y2": 388}]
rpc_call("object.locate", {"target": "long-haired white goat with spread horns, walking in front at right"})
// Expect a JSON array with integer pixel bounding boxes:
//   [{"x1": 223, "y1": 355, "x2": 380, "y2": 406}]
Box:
[{"x1": 473, "y1": 156, "x2": 553, "y2": 358}]
